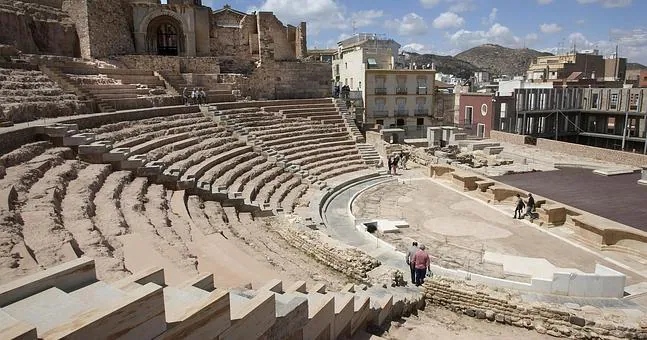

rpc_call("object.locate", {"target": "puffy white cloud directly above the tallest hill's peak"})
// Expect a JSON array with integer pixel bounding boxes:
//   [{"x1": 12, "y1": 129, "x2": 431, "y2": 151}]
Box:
[{"x1": 448, "y1": 23, "x2": 523, "y2": 50}]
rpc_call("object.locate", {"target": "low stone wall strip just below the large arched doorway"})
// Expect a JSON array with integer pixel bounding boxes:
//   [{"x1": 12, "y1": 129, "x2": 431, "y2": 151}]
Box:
[{"x1": 110, "y1": 54, "x2": 220, "y2": 73}]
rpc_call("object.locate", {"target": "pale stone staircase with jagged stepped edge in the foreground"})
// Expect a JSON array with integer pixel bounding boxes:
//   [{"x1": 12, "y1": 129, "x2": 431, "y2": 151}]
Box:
[{"x1": 0, "y1": 257, "x2": 424, "y2": 339}]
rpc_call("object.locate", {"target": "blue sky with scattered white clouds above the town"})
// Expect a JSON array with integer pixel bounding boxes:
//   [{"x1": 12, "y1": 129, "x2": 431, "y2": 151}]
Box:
[{"x1": 203, "y1": 0, "x2": 647, "y2": 64}]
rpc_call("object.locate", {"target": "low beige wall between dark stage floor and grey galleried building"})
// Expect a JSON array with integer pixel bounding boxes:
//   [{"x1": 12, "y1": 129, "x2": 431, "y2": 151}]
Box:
[{"x1": 537, "y1": 138, "x2": 647, "y2": 166}]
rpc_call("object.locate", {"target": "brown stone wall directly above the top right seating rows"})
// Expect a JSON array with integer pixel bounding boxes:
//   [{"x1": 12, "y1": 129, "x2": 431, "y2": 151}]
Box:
[{"x1": 248, "y1": 62, "x2": 332, "y2": 99}]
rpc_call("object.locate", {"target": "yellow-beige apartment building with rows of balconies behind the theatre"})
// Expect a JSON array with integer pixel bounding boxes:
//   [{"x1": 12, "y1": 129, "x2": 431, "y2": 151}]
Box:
[{"x1": 363, "y1": 69, "x2": 436, "y2": 127}]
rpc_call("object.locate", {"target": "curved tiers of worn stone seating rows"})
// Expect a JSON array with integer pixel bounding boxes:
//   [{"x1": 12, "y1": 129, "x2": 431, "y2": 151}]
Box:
[{"x1": 0, "y1": 99, "x2": 366, "y2": 279}]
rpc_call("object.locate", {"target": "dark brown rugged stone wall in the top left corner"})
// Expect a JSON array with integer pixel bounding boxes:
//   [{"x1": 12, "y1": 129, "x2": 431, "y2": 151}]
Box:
[{"x1": 0, "y1": 1, "x2": 80, "y2": 57}]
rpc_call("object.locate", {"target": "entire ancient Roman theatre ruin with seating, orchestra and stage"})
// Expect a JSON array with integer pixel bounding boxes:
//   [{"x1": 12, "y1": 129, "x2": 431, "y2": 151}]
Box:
[{"x1": 0, "y1": 0, "x2": 647, "y2": 339}]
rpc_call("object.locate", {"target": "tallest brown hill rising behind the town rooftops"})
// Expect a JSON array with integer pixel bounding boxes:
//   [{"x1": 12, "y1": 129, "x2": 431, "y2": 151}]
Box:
[{"x1": 455, "y1": 44, "x2": 551, "y2": 76}]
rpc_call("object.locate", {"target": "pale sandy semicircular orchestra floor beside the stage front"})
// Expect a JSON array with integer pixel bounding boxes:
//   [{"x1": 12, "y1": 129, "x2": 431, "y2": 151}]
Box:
[{"x1": 353, "y1": 166, "x2": 645, "y2": 284}]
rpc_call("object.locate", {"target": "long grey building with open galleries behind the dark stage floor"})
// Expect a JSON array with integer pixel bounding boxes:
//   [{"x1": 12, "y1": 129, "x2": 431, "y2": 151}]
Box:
[{"x1": 504, "y1": 88, "x2": 647, "y2": 154}]
